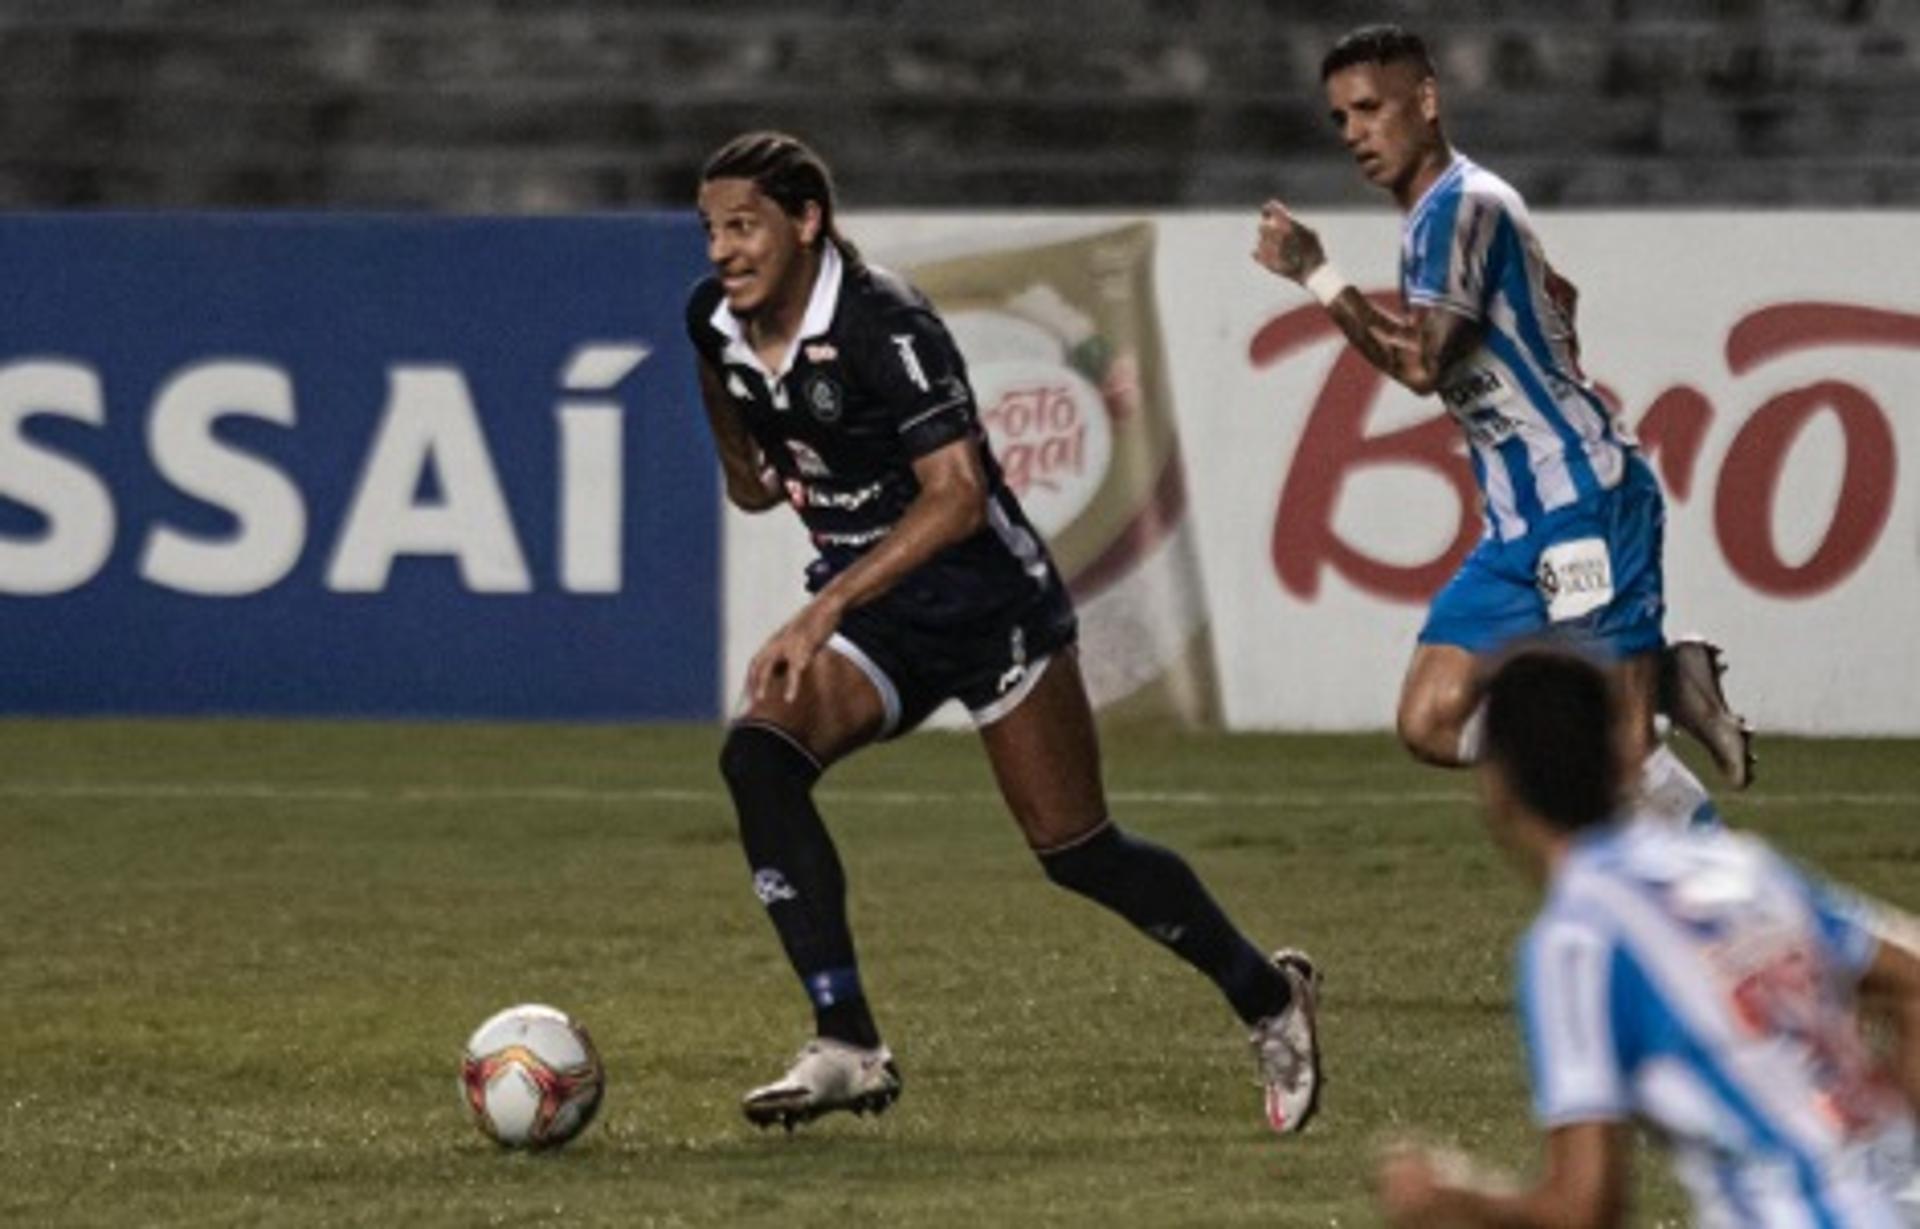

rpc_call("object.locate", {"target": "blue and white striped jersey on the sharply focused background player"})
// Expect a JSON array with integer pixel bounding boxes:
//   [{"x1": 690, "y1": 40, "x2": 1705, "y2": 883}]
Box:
[{"x1": 1400, "y1": 154, "x2": 1628, "y2": 542}]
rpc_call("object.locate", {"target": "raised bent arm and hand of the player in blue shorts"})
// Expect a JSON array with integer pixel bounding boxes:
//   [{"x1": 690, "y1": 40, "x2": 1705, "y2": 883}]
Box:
[{"x1": 1254, "y1": 200, "x2": 1480, "y2": 396}]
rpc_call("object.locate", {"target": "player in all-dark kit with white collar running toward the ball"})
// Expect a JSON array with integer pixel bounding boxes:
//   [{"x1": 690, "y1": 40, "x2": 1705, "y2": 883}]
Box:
[{"x1": 687, "y1": 133, "x2": 1319, "y2": 1131}]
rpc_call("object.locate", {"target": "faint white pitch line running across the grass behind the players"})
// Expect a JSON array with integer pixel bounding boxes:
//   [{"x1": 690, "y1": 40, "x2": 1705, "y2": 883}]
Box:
[{"x1": 0, "y1": 782, "x2": 1920, "y2": 814}]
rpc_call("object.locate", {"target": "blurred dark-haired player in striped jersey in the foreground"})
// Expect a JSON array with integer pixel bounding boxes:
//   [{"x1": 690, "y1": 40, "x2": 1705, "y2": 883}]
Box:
[{"x1": 1379, "y1": 649, "x2": 1920, "y2": 1229}]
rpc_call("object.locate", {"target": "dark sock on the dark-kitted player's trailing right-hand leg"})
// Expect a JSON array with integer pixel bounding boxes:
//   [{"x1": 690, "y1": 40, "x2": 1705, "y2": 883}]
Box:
[{"x1": 1039, "y1": 824, "x2": 1290, "y2": 1024}]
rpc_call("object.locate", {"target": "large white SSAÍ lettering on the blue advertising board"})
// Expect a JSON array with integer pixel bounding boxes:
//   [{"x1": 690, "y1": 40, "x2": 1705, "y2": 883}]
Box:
[{"x1": 0, "y1": 340, "x2": 651, "y2": 597}]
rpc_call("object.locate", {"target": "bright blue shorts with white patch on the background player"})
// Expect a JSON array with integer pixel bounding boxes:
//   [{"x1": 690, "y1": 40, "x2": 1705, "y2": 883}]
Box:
[{"x1": 1421, "y1": 455, "x2": 1667, "y2": 659}]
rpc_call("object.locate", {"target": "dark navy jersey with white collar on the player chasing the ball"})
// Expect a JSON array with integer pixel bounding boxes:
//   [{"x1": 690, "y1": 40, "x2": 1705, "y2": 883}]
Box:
[{"x1": 687, "y1": 244, "x2": 1060, "y2": 622}]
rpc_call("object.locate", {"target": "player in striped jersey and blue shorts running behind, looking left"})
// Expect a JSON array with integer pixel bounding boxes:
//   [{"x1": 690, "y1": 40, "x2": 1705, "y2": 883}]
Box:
[{"x1": 1254, "y1": 25, "x2": 1751, "y2": 824}]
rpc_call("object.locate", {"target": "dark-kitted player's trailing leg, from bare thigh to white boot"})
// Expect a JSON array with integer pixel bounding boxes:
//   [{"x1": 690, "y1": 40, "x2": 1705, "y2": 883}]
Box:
[{"x1": 981, "y1": 653, "x2": 1319, "y2": 1131}]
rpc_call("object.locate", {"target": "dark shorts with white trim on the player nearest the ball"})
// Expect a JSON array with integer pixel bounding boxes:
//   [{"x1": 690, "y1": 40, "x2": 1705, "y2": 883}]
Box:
[{"x1": 828, "y1": 576, "x2": 1079, "y2": 737}]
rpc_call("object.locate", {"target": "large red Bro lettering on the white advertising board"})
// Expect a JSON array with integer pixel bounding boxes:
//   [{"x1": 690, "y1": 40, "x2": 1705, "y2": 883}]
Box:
[{"x1": 1251, "y1": 292, "x2": 1920, "y2": 601}]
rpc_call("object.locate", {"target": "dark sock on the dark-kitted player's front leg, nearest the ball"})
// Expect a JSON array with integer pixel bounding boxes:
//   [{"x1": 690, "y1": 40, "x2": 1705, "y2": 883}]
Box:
[{"x1": 720, "y1": 724, "x2": 879, "y2": 1048}]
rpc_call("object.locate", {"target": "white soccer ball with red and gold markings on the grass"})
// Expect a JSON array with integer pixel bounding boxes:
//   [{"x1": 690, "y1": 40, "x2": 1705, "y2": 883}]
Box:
[{"x1": 461, "y1": 1002, "x2": 607, "y2": 1148}]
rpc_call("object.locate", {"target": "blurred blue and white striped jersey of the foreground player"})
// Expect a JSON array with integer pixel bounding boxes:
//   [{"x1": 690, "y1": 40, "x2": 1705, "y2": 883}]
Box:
[{"x1": 1519, "y1": 820, "x2": 1916, "y2": 1229}]
